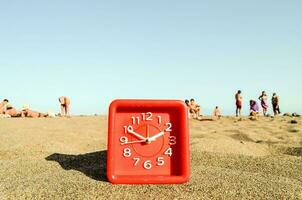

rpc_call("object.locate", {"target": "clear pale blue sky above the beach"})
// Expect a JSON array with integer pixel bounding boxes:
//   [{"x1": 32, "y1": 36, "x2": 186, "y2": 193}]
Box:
[{"x1": 0, "y1": 0, "x2": 302, "y2": 114}]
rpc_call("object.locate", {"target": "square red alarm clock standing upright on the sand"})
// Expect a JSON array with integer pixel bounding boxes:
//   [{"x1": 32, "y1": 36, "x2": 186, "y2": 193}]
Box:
[{"x1": 107, "y1": 100, "x2": 190, "y2": 184}]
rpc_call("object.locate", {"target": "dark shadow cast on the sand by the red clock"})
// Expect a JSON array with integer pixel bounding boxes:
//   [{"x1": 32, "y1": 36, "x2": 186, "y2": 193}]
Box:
[{"x1": 45, "y1": 151, "x2": 107, "y2": 182}]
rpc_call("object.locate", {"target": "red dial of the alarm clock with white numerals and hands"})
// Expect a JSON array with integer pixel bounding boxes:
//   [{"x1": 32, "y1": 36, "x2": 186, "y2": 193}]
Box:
[{"x1": 117, "y1": 112, "x2": 177, "y2": 174}]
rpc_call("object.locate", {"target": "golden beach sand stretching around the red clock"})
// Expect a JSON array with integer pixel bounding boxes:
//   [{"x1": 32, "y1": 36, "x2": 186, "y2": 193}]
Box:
[{"x1": 0, "y1": 116, "x2": 302, "y2": 199}]
